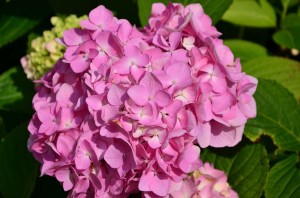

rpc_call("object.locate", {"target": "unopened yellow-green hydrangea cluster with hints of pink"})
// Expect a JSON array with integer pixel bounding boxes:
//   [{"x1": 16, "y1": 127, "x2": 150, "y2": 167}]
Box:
[{"x1": 21, "y1": 15, "x2": 87, "y2": 80}]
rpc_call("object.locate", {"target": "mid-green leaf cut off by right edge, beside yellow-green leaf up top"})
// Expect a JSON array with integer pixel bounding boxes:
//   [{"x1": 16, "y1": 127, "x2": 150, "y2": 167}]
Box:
[{"x1": 273, "y1": 14, "x2": 300, "y2": 50}]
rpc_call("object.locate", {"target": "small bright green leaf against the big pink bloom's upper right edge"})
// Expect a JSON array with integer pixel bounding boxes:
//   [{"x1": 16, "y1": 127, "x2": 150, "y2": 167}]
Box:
[{"x1": 224, "y1": 39, "x2": 268, "y2": 63}]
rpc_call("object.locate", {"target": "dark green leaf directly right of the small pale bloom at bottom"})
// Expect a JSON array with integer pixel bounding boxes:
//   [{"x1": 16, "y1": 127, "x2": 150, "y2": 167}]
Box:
[{"x1": 201, "y1": 144, "x2": 269, "y2": 198}]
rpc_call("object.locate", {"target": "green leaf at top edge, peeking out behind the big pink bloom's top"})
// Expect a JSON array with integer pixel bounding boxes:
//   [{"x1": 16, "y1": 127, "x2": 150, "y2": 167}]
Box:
[{"x1": 137, "y1": 0, "x2": 233, "y2": 26}]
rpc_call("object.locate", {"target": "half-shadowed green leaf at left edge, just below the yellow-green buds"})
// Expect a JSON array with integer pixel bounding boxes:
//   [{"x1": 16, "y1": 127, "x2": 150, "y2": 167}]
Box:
[{"x1": 0, "y1": 66, "x2": 34, "y2": 113}]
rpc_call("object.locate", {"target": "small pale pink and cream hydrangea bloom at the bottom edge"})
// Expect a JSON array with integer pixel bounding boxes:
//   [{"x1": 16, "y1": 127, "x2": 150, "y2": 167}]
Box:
[{"x1": 171, "y1": 163, "x2": 238, "y2": 198}]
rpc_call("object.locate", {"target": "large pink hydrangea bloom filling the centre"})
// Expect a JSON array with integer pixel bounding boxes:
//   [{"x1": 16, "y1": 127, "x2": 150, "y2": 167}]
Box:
[{"x1": 28, "y1": 3, "x2": 257, "y2": 197}]
